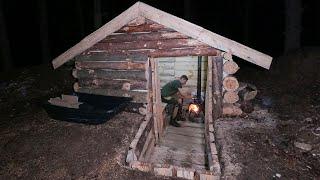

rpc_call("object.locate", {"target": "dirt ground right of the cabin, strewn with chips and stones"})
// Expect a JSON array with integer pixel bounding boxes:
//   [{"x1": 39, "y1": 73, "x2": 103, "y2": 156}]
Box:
[{"x1": 215, "y1": 49, "x2": 320, "y2": 179}]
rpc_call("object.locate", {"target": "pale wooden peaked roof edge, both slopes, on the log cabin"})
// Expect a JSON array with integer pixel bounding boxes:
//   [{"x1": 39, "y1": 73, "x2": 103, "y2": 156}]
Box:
[{"x1": 52, "y1": 2, "x2": 272, "y2": 69}]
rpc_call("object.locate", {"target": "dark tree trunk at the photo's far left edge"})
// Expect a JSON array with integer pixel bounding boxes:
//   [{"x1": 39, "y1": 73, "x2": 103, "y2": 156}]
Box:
[{"x1": 0, "y1": 1, "x2": 13, "y2": 71}]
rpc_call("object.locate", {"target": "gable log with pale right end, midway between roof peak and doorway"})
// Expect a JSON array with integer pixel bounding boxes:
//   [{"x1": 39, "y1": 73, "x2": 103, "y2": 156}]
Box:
[{"x1": 100, "y1": 31, "x2": 189, "y2": 43}]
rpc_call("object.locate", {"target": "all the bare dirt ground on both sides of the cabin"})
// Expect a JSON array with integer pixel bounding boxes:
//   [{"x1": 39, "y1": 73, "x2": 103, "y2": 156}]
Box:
[{"x1": 0, "y1": 49, "x2": 320, "y2": 179}]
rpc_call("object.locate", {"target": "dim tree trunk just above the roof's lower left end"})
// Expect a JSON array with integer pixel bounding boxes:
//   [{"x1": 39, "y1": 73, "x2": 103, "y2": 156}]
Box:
[{"x1": 38, "y1": 0, "x2": 50, "y2": 63}]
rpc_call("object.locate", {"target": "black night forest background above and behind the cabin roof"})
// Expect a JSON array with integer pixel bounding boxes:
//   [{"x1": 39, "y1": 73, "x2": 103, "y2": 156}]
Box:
[{"x1": 0, "y1": 0, "x2": 320, "y2": 71}]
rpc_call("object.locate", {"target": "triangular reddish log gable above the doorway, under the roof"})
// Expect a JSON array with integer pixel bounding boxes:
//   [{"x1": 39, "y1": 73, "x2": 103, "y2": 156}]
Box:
[{"x1": 85, "y1": 20, "x2": 218, "y2": 57}]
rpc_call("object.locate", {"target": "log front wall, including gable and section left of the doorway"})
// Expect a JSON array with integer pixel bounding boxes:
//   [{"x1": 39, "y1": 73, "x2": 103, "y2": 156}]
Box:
[{"x1": 73, "y1": 17, "x2": 218, "y2": 103}]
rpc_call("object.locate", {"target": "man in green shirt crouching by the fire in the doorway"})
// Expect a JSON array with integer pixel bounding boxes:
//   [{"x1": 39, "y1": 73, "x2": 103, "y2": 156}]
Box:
[{"x1": 161, "y1": 75, "x2": 189, "y2": 127}]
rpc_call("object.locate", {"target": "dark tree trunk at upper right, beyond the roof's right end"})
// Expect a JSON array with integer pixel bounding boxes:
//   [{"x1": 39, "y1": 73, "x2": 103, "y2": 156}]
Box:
[{"x1": 284, "y1": 0, "x2": 302, "y2": 53}]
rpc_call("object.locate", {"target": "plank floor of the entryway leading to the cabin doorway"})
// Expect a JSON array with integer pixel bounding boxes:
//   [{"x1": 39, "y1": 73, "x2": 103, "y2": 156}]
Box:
[{"x1": 148, "y1": 122, "x2": 207, "y2": 170}]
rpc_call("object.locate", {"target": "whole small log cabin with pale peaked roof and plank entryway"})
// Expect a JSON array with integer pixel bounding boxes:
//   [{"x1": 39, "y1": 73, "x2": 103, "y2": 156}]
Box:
[{"x1": 52, "y1": 2, "x2": 272, "y2": 179}]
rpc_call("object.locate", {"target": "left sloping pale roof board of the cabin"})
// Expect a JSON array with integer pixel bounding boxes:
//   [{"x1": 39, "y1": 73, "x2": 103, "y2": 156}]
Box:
[{"x1": 52, "y1": 3, "x2": 139, "y2": 69}]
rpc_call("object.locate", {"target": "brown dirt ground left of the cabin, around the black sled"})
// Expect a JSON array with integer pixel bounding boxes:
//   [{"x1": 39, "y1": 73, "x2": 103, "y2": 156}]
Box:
[{"x1": 0, "y1": 66, "x2": 182, "y2": 180}]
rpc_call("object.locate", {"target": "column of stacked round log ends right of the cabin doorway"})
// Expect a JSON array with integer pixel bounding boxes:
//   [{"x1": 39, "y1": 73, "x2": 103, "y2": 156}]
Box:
[{"x1": 222, "y1": 53, "x2": 257, "y2": 116}]
